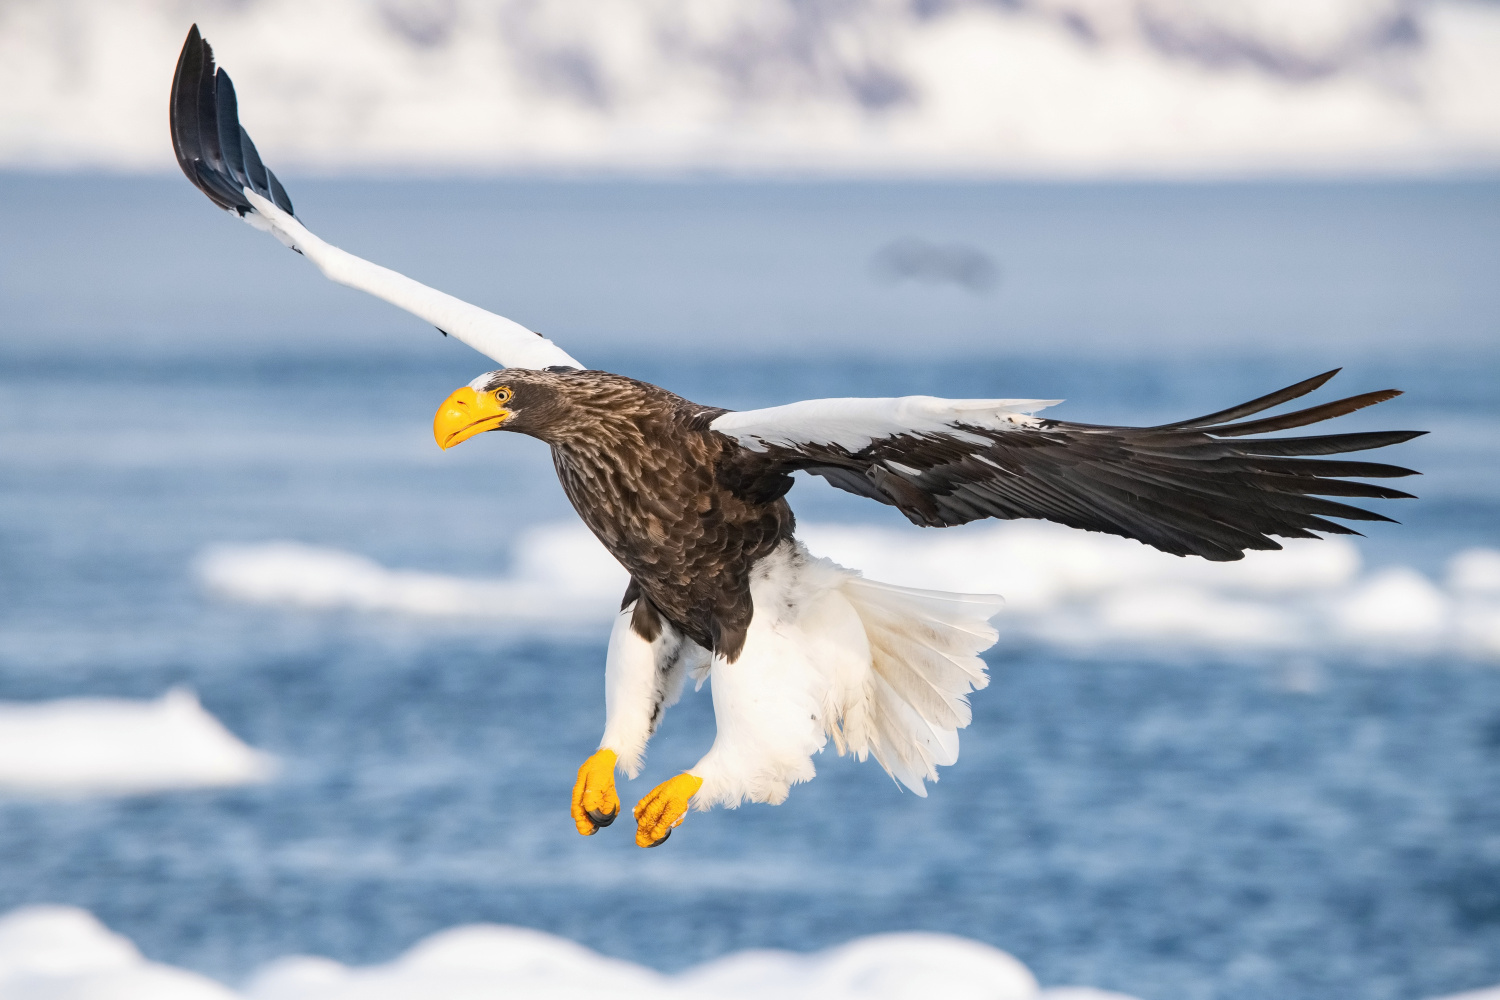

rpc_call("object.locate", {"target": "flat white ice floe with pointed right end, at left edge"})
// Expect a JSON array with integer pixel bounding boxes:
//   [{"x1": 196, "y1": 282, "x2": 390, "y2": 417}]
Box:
[{"x1": 0, "y1": 688, "x2": 276, "y2": 797}]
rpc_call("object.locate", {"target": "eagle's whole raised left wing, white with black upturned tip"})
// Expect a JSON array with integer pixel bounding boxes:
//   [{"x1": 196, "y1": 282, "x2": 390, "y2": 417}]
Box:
[{"x1": 171, "y1": 24, "x2": 584, "y2": 369}]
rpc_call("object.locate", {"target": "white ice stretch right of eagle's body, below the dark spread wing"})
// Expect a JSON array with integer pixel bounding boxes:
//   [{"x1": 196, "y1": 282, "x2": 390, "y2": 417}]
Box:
[{"x1": 803, "y1": 522, "x2": 1500, "y2": 658}]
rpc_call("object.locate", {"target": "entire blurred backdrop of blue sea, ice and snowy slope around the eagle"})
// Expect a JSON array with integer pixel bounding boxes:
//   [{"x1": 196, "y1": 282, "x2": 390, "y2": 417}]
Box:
[{"x1": 0, "y1": 0, "x2": 1500, "y2": 1000}]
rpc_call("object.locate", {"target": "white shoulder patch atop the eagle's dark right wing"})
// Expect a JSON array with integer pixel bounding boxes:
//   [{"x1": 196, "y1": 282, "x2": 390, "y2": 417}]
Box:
[{"x1": 708, "y1": 396, "x2": 1062, "y2": 451}]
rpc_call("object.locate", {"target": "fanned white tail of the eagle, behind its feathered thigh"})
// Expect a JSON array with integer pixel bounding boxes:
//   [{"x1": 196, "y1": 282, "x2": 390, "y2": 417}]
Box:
[{"x1": 828, "y1": 576, "x2": 1002, "y2": 795}]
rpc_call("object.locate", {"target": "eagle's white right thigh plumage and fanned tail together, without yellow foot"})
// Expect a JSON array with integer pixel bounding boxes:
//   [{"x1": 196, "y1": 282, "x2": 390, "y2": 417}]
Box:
[{"x1": 689, "y1": 543, "x2": 1001, "y2": 810}]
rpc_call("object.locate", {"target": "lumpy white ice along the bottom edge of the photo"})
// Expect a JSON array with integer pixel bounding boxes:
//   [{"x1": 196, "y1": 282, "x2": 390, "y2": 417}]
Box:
[{"x1": 0, "y1": 906, "x2": 1131, "y2": 1000}]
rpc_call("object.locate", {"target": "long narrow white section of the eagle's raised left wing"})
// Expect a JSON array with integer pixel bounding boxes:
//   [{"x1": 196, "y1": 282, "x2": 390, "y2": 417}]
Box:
[{"x1": 245, "y1": 187, "x2": 584, "y2": 369}]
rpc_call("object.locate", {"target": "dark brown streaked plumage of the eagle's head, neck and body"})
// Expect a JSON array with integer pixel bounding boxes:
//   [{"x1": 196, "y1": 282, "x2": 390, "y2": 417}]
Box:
[{"x1": 485, "y1": 370, "x2": 795, "y2": 658}]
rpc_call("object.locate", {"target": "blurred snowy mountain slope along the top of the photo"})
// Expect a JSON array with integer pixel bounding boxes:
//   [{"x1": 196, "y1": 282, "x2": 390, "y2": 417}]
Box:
[{"x1": 0, "y1": 0, "x2": 1500, "y2": 174}]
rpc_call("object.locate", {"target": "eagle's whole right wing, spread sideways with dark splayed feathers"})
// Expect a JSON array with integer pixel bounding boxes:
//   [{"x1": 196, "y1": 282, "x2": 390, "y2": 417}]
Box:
[{"x1": 710, "y1": 369, "x2": 1425, "y2": 561}]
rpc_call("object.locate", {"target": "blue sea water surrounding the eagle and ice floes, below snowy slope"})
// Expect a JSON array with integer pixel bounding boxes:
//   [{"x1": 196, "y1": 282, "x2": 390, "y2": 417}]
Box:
[{"x1": 0, "y1": 175, "x2": 1500, "y2": 1000}]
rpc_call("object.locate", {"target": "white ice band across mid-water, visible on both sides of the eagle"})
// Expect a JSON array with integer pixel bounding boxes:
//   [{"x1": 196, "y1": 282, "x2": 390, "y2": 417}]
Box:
[{"x1": 198, "y1": 522, "x2": 1500, "y2": 658}]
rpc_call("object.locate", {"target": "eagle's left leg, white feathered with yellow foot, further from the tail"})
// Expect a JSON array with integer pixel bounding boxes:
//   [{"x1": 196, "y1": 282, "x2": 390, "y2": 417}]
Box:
[{"x1": 572, "y1": 593, "x2": 698, "y2": 837}]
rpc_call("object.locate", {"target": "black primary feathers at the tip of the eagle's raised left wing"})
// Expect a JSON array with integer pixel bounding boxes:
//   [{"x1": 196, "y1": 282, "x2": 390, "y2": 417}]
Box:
[{"x1": 171, "y1": 24, "x2": 296, "y2": 216}]
